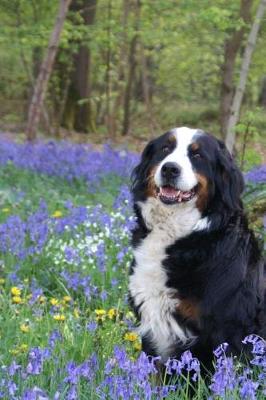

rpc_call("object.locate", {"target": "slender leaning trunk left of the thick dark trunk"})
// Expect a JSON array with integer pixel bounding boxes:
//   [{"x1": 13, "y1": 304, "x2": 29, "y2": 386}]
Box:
[{"x1": 27, "y1": 0, "x2": 71, "y2": 140}]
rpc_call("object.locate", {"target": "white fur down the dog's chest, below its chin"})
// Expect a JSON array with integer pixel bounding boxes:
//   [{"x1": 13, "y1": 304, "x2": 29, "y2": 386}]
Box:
[{"x1": 129, "y1": 198, "x2": 201, "y2": 361}]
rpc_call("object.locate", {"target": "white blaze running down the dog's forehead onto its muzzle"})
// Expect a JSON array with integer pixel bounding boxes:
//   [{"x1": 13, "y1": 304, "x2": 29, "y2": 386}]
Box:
[{"x1": 154, "y1": 127, "x2": 200, "y2": 191}]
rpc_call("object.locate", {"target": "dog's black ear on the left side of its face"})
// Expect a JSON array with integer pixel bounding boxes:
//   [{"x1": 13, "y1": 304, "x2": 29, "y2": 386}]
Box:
[{"x1": 131, "y1": 141, "x2": 154, "y2": 193}]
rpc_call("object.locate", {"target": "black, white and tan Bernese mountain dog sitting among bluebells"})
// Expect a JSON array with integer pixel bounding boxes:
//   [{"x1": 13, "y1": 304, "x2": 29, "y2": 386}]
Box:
[{"x1": 129, "y1": 127, "x2": 265, "y2": 368}]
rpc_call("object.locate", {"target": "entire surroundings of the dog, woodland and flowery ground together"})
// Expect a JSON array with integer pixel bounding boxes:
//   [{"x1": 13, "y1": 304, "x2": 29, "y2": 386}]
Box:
[{"x1": 0, "y1": 0, "x2": 266, "y2": 400}]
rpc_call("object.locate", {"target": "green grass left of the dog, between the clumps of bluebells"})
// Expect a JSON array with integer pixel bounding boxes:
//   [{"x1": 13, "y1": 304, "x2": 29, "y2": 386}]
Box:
[{"x1": 0, "y1": 165, "x2": 132, "y2": 391}]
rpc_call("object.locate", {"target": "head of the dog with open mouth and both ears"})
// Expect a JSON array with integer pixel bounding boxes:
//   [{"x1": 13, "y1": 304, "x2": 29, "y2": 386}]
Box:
[{"x1": 132, "y1": 127, "x2": 244, "y2": 213}]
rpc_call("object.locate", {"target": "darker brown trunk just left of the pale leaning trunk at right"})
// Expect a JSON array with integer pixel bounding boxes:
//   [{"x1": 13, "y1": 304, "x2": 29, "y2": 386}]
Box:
[{"x1": 220, "y1": 0, "x2": 252, "y2": 138}]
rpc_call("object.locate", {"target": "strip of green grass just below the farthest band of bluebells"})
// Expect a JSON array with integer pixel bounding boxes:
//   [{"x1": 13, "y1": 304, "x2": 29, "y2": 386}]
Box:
[{"x1": 0, "y1": 164, "x2": 127, "y2": 222}]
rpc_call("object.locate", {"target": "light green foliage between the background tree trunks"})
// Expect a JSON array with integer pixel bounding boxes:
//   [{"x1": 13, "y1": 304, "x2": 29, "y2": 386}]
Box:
[{"x1": 0, "y1": 0, "x2": 266, "y2": 138}]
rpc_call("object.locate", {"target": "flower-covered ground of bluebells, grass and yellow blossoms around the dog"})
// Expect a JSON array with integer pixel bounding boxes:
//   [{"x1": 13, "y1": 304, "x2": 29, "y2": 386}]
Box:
[{"x1": 0, "y1": 139, "x2": 266, "y2": 400}]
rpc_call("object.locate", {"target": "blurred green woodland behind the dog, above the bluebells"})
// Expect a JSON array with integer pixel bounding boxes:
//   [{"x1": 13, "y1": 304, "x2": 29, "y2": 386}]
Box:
[{"x1": 0, "y1": 0, "x2": 266, "y2": 169}]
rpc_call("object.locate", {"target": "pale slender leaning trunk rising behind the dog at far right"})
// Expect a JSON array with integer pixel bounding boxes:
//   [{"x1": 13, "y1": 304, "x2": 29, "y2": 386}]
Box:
[{"x1": 225, "y1": 0, "x2": 266, "y2": 152}]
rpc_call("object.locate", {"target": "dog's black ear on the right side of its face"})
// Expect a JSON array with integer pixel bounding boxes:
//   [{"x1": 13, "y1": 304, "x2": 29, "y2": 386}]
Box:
[{"x1": 216, "y1": 140, "x2": 244, "y2": 210}]
